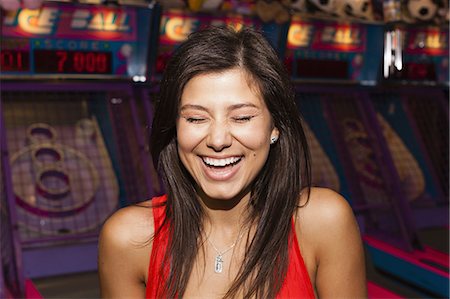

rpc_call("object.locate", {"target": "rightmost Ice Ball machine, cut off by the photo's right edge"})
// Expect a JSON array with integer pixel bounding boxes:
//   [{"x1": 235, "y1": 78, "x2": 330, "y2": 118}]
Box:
[{"x1": 366, "y1": 19, "x2": 449, "y2": 297}]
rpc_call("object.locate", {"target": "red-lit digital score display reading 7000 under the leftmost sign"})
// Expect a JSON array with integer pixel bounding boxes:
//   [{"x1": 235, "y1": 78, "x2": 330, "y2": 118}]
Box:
[{"x1": 33, "y1": 50, "x2": 112, "y2": 75}]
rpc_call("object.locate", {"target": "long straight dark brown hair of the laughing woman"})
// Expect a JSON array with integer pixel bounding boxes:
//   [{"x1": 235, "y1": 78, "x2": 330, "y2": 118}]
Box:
[{"x1": 150, "y1": 27, "x2": 311, "y2": 298}]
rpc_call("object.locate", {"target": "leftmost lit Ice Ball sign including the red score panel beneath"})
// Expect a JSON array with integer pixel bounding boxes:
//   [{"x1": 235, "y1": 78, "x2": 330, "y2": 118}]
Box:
[{"x1": 0, "y1": 3, "x2": 152, "y2": 77}]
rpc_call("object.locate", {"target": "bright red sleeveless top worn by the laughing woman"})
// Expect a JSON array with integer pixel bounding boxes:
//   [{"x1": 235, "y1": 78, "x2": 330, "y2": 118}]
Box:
[{"x1": 145, "y1": 195, "x2": 315, "y2": 299}]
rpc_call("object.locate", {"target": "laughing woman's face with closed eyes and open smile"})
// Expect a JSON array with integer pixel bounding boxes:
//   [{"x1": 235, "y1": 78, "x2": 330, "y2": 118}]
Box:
[{"x1": 177, "y1": 68, "x2": 278, "y2": 200}]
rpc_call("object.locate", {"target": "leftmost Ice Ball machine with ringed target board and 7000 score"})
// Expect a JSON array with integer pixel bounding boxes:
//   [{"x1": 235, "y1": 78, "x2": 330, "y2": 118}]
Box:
[{"x1": 0, "y1": 2, "x2": 158, "y2": 284}]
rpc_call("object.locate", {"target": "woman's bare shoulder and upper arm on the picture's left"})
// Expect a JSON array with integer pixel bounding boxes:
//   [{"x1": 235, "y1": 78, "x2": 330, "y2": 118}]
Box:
[{"x1": 98, "y1": 201, "x2": 154, "y2": 298}]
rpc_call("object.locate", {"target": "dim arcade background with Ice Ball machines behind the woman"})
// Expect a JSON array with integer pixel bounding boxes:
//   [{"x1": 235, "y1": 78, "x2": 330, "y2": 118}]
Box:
[{"x1": 0, "y1": 0, "x2": 449, "y2": 299}]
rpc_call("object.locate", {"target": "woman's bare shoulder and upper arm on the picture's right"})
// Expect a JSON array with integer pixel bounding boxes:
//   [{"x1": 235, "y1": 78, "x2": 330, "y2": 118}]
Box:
[{"x1": 295, "y1": 188, "x2": 367, "y2": 298}]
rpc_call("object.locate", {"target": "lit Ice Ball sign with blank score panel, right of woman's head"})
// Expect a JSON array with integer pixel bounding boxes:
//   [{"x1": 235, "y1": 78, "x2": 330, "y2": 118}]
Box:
[{"x1": 285, "y1": 18, "x2": 367, "y2": 80}]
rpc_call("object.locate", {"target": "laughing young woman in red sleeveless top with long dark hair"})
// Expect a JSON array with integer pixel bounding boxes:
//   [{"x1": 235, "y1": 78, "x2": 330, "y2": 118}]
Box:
[{"x1": 99, "y1": 28, "x2": 366, "y2": 298}]
